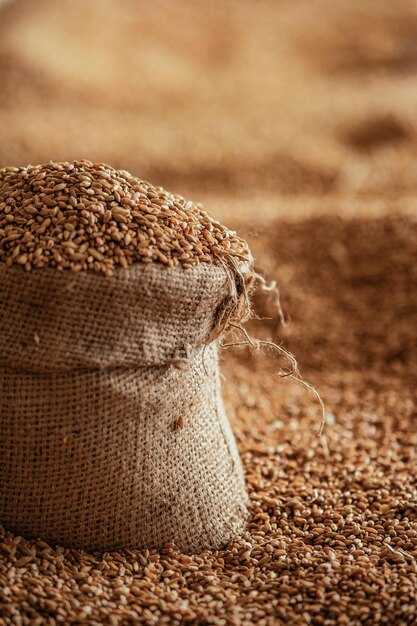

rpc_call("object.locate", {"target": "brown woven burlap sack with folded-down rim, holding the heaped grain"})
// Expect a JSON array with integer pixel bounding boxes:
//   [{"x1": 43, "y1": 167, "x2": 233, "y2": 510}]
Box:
[{"x1": 0, "y1": 264, "x2": 247, "y2": 551}]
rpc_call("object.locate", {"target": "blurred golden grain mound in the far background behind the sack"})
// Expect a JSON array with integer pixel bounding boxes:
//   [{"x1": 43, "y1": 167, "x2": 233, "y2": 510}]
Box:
[{"x1": 0, "y1": 0, "x2": 417, "y2": 213}]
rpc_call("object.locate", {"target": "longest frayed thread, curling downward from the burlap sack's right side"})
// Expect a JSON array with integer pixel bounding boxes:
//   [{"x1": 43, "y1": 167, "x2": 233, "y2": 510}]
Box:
[{"x1": 219, "y1": 322, "x2": 326, "y2": 437}]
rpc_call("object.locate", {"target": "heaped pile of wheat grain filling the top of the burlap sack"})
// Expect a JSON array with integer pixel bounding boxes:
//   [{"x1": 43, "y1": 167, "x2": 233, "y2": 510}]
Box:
[{"x1": 0, "y1": 161, "x2": 249, "y2": 274}]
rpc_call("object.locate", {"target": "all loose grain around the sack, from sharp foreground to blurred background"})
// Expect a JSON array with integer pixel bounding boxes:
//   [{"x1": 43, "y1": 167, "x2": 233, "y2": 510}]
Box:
[{"x1": 0, "y1": 0, "x2": 417, "y2": 626}]
